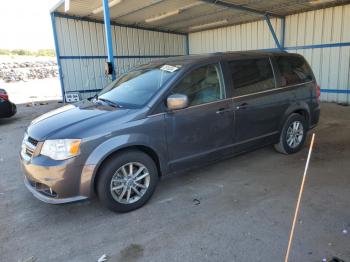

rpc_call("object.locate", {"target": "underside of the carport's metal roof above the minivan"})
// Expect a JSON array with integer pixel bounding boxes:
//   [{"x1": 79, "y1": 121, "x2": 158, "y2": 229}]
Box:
[{"x1": 51, "y1": 0, "x2": 350, "y2": 33}]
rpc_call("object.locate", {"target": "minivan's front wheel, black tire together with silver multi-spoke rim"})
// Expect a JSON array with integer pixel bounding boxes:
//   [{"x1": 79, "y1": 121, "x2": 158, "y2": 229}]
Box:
[{"x1": 97, "y1": 150, "x2": 159, "y2": 212}]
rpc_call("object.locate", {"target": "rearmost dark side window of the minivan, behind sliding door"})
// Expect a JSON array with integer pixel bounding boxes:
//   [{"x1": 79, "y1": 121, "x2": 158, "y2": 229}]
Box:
[{"x1": 276, "y1": 56, "x2": 313, "y2": 87}]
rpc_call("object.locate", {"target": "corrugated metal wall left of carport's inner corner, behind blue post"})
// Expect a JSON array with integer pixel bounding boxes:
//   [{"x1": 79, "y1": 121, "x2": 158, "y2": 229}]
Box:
[{"x1": 55, "y1": 17, "x2": 186, "y2": 98}]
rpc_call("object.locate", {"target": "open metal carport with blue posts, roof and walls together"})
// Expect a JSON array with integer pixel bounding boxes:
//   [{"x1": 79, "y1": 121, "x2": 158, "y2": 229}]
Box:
[{"x1": 51, "y1": 0, "x2": 350, "y2": 101}]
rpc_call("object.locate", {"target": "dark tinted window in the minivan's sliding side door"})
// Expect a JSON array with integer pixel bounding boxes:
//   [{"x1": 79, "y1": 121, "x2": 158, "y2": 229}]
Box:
[{"x1": 228, "y1": 58, "x2": 275, "y2": 96}]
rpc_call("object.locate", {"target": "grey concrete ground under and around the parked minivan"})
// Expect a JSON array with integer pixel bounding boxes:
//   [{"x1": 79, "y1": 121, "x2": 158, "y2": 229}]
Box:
[{"x1": 0, "y1": 103, "x2": 350, "y2": 262}]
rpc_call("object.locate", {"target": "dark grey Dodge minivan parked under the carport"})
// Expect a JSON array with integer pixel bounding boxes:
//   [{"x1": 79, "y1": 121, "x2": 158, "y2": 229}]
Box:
[{"x1": 20, "y1": 52, "x2": 320, "y2": 212}]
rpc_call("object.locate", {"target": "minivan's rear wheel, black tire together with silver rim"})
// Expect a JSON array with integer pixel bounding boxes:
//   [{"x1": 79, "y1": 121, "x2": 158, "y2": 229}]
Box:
[{"x1": 274, "y1": 113, "x2": 307, "y2": 155}]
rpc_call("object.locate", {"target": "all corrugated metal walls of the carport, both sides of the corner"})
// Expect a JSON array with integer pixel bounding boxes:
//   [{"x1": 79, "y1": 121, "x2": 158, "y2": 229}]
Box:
[{"x1": 55, "y1": 5, "x2": 350, "y2": 102}]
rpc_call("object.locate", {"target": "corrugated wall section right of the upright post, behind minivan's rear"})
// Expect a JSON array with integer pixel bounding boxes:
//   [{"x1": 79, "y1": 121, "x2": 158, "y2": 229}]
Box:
[{"x1": 286, "y1": 5, "x2": 350, "y2": 102}]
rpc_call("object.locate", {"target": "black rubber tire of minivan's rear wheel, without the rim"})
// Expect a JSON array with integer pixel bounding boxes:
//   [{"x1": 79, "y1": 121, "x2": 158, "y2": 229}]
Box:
[{"x1": 281, "y1": 114, "x2": 307, "y2": 154}]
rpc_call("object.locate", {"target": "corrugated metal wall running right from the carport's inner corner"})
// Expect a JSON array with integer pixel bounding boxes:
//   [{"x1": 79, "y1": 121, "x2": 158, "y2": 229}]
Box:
[{"x1": 189, "y1": 5, "x2": 350, "y2": 103}]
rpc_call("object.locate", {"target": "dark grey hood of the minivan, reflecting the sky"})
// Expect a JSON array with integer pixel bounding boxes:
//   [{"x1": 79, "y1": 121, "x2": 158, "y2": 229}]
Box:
[{"x1": 27, "y1": 100, "x2": 129, "y2": 141}]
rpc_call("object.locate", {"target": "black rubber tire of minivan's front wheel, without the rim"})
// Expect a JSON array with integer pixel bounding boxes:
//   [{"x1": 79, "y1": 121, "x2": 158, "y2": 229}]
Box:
[{"x1": 97, "y1": 151, "x2": 159, "y2": 212}]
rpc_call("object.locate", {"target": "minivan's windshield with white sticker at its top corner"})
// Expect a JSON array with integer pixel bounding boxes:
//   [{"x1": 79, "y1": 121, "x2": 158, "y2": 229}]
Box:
[{"x1": 98, "y1": 64, "x2": 178, "y2": 107}]
